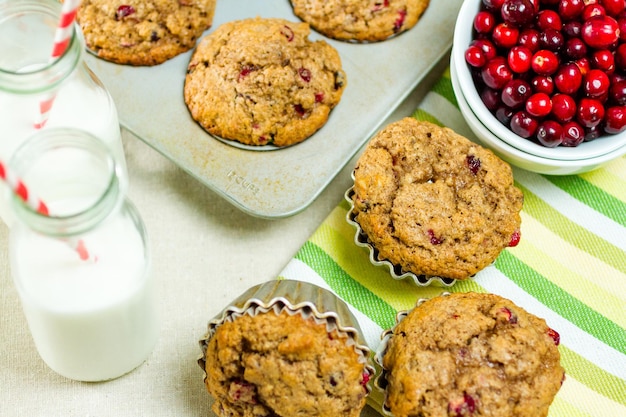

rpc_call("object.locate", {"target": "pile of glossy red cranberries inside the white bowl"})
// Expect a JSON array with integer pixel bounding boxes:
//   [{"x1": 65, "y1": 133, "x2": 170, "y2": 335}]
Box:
[{"x1": 465, "y1": 0, "x2": 626, "y2": 147}]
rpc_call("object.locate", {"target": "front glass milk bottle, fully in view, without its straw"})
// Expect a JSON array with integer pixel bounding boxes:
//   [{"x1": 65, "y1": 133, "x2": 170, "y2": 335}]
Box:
[{"x1": 8, "y1": 128, "x2": 159, "y2": 381}]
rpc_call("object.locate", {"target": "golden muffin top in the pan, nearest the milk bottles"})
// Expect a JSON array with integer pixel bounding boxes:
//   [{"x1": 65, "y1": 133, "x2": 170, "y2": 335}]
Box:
[{"x1": 76, "y1": 0, "x2": 215, "y2": 66}]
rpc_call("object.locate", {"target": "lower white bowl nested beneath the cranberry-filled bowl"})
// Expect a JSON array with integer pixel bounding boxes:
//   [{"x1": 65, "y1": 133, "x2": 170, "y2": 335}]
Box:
[{"x1": 450, "y1": 55, "x2": 626, "y2": 175}]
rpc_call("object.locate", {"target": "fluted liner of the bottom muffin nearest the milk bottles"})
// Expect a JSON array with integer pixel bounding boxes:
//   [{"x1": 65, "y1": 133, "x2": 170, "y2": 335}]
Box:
[{"x1": 198, "y1": 280, "x2": 375, "y2": 394}]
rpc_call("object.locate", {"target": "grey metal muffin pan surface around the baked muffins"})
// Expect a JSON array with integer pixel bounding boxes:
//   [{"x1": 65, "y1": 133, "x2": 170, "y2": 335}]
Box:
[{"x1": 86, "y1": 0, "x2": 463, "y2": 218}]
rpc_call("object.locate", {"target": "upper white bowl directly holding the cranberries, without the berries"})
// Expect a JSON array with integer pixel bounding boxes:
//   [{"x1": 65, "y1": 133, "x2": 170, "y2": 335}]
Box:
[{"x1": 452, "y1": 0, "x2": 626, "y2": 161}]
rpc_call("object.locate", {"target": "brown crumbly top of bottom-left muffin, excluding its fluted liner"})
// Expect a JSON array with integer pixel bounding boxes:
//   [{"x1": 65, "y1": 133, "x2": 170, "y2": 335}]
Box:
[{"x1": 205, "y1": 311, "x2": 367, "y2": 417}]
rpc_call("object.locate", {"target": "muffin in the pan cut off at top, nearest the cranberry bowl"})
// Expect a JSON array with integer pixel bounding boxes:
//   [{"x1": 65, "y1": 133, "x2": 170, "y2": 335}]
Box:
[{"x1": 291, "y1": 0, "x2": 429, "y2": 42}]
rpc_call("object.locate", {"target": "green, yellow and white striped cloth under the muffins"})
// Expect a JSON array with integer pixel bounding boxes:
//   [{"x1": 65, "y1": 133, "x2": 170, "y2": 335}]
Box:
[{"x1": 280, "y1": 66, "x2": 626, "y2": 417}]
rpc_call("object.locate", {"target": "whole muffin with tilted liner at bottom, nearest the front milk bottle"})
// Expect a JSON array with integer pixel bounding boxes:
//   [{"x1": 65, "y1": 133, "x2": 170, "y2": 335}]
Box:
[{"x1": 199, "y1": 280, "x2": 374, "y2": 417}]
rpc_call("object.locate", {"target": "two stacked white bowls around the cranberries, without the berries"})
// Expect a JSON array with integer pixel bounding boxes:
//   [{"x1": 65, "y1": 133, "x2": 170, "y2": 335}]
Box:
[{"x1": 450, "y1": 0, "x2": 626, "y2": 175}]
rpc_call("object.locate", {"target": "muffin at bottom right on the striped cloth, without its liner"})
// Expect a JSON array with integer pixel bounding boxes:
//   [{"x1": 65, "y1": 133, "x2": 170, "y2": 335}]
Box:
[{"x1": 383, "y1": 293, "x2": 564, "y2": 417}]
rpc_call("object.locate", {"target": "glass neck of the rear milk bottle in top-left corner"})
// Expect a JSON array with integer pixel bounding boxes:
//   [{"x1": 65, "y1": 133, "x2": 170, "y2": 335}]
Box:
[{"x1": 0, "y1": 0, "x2": 85, "y2": 94}]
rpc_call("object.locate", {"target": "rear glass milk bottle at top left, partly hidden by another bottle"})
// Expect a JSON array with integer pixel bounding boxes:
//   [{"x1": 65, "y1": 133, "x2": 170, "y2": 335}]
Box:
[{"x1": 0, "y1": 0, "x2": 126, "y2": 226}]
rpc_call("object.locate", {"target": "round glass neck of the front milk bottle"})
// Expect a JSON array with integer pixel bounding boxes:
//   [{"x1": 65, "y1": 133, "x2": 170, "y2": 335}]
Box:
[{"x1": 9, "y1": 128, "x2": 126, "y2": 238}]
